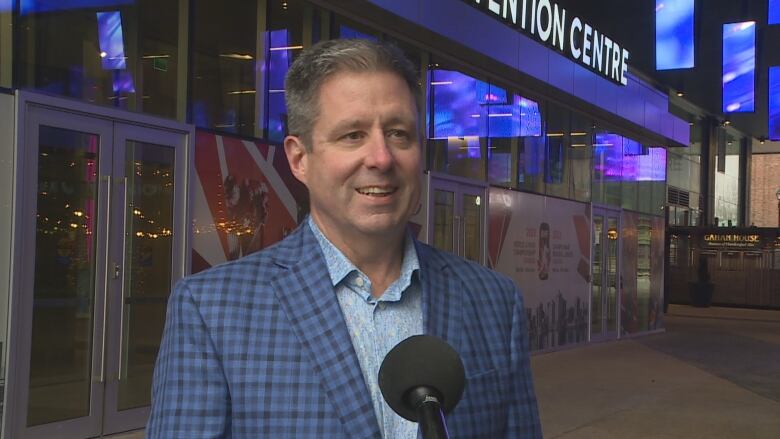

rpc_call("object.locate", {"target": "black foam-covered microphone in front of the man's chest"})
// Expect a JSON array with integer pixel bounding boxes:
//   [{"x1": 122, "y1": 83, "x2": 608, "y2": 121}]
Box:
[{"x1": 379, "y1": 335, "x2": 466, "y2": 439}]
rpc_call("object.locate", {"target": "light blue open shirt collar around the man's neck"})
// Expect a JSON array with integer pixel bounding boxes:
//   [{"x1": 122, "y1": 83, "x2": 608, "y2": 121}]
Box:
[{"x1": 307, "y1": 216, "x2": 420, "y2": 300}]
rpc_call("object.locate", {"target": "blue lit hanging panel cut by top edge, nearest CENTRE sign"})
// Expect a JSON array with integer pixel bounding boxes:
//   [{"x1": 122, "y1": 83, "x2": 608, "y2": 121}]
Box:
[{"x1": 655, "y1": 0, "x2": 695, "y2": 70}]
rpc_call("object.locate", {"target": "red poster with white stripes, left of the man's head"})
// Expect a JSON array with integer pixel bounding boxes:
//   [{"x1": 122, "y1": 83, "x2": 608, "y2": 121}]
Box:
[{"x1": 192, "y1": 131, "x2": 307, "y2": 273}]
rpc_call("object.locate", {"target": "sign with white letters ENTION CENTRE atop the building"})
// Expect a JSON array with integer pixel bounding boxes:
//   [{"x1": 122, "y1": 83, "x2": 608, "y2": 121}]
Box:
[{"x1": 465, "y1": 0, "x2": 629, "y2": 85}]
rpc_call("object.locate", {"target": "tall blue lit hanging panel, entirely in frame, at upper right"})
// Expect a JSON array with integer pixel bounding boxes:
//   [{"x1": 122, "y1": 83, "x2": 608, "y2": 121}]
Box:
[{"x1": 723, "y1": 21, "x2": 756, "y2": 113}]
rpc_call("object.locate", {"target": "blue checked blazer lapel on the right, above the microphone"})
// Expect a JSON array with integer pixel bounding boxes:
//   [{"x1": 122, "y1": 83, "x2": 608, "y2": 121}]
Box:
[{"x1": 415, "y1": 241, "x2": 463, "y2": 352}]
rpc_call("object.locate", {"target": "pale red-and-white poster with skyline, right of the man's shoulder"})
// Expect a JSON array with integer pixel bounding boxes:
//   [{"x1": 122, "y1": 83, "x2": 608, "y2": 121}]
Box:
[{"x1": 488, "y1": 188, "x2": 590, "y2": 350}]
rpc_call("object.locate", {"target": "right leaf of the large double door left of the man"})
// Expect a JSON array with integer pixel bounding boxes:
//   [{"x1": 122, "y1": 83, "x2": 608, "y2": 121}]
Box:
[{"x1": 103, "y1": 124, "x2": 184, "y2": 434}]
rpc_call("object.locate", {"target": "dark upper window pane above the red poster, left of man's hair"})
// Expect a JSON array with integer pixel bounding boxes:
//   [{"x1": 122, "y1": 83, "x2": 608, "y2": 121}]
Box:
[{"x1": 191, "y1": 0, "x2": 258, "y2": 136}]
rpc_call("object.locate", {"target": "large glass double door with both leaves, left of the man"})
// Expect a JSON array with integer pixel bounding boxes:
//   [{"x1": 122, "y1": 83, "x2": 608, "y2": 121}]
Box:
[{"x1": 7, "y1": 96, "x2": 189, "y2": 438}]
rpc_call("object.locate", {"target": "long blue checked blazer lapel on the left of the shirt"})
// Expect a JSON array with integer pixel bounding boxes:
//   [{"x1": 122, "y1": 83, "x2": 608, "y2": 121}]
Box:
[{"x1": 273, "y1": 227, "x2": 380, "y2": 438}]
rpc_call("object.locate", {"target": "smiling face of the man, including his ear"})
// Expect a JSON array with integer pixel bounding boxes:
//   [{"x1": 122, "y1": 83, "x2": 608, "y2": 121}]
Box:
[{"x1": 285, "y1": 72, "x2": 422, "y2": 245}]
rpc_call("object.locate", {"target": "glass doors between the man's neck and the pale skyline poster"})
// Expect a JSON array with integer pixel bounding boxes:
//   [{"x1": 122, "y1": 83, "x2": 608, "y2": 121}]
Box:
[{"x1": 428, "y1": 174, "x2": 487, "y2": 264}]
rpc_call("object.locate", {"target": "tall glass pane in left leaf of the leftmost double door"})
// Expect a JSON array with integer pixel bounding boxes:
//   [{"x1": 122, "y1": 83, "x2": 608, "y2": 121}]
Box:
[{"x1": 27, "y1": 126, "x2": 99, "y2": 426}]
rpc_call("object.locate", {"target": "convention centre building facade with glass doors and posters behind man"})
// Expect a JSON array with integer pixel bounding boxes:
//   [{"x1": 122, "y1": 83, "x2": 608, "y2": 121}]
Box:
[{"x1": 0, "y1": 0, "x2": 704, "y2": 438}]
